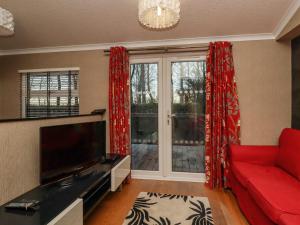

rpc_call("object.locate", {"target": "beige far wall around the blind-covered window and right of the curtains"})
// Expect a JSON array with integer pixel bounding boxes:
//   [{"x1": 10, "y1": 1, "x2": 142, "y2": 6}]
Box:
[{"x1": 0, "y1": 40, "x2": 291, "y2": 144}]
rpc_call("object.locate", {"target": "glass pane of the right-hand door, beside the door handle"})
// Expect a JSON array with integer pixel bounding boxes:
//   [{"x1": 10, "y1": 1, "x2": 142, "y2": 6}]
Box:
[{"x1": 168, "y1": 60, "x2": 206, "y2": 173}]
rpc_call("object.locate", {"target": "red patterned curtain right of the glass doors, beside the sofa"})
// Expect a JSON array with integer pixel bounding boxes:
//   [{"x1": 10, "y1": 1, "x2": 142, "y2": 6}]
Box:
[{"x1": 205, "y1": 42, "x2": 240, "y2": 188}]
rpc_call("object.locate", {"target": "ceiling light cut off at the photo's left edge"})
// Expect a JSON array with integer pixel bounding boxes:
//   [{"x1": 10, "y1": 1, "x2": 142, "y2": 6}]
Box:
[{"x1": 0, "y1": 7, "x2": 15, "y2": 36}]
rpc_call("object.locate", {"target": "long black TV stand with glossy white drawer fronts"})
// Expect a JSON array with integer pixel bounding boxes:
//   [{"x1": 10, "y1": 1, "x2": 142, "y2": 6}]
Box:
[{"x1": 0, "y1": 156, "x2": 130, "y2": 225}]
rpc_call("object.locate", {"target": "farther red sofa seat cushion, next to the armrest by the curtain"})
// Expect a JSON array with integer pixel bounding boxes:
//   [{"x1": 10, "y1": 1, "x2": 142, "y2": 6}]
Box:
[{"x1": 231, "y1": 162, "x2": 278, "y2": 188}]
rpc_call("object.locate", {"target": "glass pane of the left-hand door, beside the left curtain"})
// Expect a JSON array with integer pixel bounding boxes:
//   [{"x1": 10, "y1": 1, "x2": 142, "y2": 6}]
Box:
[{"x1": 130, "y1": 63, "x2": 159, "y2": 171}]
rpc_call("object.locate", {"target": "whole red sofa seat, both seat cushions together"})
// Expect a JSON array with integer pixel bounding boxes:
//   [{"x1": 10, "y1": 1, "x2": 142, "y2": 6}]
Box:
[{"x1": 231, "y1": 162, "x2": 300, "y2": 225}]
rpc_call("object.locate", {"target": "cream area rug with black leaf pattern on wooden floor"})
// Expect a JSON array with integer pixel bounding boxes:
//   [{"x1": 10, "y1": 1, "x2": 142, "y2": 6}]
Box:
[{"x1": 123, "y1": 192, "x2": 214, "y2": 225}]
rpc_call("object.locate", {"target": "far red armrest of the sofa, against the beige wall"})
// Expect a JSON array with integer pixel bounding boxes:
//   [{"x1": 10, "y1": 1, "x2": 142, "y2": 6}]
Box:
[{"x1": 229, "y1": 145, "x2": 279, "y2": 165}]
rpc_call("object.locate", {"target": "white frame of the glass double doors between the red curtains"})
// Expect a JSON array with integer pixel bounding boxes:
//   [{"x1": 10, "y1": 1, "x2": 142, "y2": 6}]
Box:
[{"x1": 130, "y1": 55, "x2": 206, "y2": 182}]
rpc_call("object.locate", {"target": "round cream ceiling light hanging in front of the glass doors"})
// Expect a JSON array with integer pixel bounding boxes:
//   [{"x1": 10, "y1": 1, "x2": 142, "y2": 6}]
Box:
[{"x1": 139, "y1": 0, "x2": 180, "y2": 29}]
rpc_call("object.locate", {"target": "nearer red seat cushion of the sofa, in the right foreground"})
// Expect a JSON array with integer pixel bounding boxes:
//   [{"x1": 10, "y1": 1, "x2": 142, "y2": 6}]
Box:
[{"x1": 247, "y1": 167, "x2": 300, "y2": 224}]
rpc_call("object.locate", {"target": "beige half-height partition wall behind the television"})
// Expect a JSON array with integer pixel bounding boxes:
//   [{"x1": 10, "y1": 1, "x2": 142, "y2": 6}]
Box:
[{"x1": 0, "y1": 116, "x2": 102, "y2": 205}]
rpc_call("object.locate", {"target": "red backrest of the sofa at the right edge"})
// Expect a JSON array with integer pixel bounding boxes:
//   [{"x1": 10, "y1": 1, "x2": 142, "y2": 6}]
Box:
[{"x1": 276, "y1": 128, "x2": 300, "y2": 180}]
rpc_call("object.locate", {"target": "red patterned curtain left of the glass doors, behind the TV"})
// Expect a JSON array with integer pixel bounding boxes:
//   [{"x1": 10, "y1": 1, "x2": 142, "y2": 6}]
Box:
[{"x1": 109, "y1": 47, "x2": 130, "y2": 155}]
